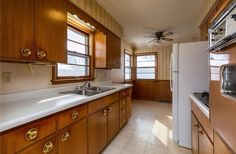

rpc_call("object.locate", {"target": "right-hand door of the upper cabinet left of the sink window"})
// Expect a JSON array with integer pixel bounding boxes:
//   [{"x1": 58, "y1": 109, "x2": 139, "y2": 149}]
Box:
[{"x1": 35, "y1": 0, "x2": 67, "y2": 63}]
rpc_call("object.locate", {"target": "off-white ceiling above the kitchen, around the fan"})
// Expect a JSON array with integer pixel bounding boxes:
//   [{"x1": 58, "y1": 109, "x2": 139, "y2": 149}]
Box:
[{"x1": 97, "y1": 0, "x2": 203, "y2": 47}]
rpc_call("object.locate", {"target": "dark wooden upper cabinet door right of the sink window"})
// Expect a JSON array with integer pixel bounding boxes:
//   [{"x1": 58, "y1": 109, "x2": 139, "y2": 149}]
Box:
[{"x1": 107, "y1": 33, "x2": 121, "y2": 68}]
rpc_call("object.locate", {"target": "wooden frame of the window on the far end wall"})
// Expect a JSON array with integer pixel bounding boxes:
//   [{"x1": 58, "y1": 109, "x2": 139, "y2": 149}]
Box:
[{"x1": 134, "y1": 52, "x2": 158, "y2": 81}]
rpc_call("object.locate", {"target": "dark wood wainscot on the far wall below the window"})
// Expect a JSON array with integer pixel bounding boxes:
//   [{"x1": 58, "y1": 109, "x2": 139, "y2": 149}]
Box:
[{"x1": 133, "y1": 80, "x2": 172, "y2": 101}]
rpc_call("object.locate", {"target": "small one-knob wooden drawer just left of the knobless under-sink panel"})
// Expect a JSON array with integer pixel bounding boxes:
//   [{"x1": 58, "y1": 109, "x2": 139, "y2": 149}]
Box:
[{"x1": 57, "y1": 104, "x2": 88, "y2": 129}]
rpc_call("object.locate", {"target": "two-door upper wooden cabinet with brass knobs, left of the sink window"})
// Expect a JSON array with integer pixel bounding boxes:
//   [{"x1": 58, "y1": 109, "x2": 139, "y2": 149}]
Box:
[{"x1": 0, "y1": 0, "x2": 67, "y2": 62}]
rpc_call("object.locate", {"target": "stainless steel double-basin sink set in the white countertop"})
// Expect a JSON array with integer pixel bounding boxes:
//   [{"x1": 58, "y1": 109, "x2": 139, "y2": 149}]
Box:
[{"x1": 60, "y1": 86, "x2": 115, "y2": 96}]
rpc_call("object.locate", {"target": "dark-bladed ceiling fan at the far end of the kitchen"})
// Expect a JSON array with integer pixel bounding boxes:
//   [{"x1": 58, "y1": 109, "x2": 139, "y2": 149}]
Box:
[{"x1": 145, "y1": 32, "x2": 173, "y2": 44}]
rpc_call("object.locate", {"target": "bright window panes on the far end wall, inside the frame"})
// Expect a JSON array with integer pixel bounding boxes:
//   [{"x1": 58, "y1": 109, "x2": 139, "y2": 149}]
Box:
[{"x1": 136, "y1": 55, "x2": 156, "y2": 79}]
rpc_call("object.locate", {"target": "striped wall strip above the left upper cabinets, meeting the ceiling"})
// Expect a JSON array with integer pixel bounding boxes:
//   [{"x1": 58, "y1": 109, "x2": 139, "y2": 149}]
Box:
[{"x1": 70, "y1": 0, "x2": 123, "y2": 38}]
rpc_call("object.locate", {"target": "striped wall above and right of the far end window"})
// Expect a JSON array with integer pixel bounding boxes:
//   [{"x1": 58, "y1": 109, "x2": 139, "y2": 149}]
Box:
[{"x1": 134, "y1": 45, "x2": 172, "y2": 80}]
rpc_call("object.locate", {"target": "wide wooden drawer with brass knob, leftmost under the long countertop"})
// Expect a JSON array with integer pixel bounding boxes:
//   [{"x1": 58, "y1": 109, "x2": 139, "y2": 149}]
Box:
[{"x1": 1, "y1": 116, "x2": 56, "y2": 154}]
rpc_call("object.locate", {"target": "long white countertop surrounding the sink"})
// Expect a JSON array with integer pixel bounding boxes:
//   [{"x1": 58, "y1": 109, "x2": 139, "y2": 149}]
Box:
[{"x1": 0, "y1": 84, "x2": 132, "y2": 132}]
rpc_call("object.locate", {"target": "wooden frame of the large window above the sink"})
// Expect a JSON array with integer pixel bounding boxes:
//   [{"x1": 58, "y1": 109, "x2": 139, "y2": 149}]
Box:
[{"x1": 51, "y1": 22, "x2": 94, "y2": 84}]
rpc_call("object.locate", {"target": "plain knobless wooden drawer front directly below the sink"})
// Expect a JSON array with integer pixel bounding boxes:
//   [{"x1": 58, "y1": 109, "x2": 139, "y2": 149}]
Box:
[{"x1": 88, "y1": 93, "x2": 119, "y2": 114}]
